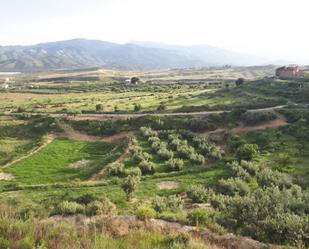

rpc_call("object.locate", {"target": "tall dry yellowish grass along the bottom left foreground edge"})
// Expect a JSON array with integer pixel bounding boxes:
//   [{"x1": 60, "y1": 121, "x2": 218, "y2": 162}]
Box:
[{"x1": 0, "y1": 204, "x2": 206, "y2": 249}]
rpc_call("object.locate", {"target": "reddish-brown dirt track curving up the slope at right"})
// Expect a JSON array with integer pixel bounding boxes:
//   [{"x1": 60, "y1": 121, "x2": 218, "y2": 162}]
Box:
[{"x1": 201, "y1": 111, "x2": 288, "y2": 138}]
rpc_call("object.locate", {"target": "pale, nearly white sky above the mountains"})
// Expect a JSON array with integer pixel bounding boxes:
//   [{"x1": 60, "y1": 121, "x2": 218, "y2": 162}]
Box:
[{"x1": 0, "y1": 0, "x2": 309, "y2": 63}]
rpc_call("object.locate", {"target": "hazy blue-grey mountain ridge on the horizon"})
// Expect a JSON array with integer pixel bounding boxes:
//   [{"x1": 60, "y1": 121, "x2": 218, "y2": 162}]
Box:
[{"x1": 0, "y1": 39, "x2": 265, "y2": 72}]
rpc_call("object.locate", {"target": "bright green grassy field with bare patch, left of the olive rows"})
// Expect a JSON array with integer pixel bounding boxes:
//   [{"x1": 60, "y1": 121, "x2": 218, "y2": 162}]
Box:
[{"x1": 5, "y1": 139, "x2": 122, "y2": 184}]
